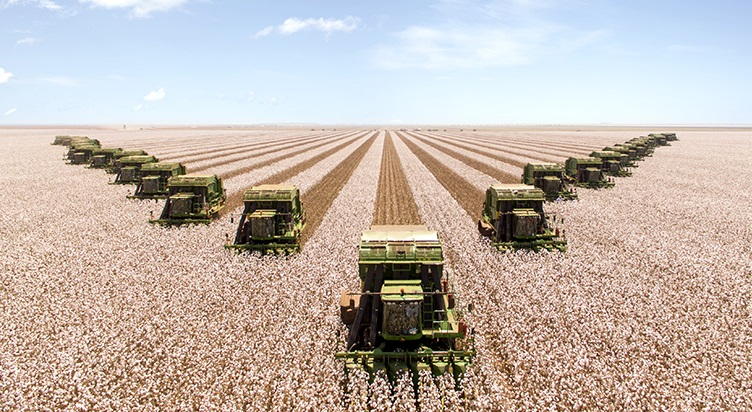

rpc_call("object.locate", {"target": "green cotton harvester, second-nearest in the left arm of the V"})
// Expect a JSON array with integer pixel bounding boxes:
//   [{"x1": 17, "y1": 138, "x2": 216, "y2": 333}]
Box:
[{"x1": 149, "y1": 175, "x2": 225, "y2": 225}]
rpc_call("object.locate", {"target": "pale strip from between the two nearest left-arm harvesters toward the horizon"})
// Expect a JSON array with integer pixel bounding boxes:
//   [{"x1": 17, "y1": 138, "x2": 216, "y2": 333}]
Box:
[{"x1": 223, "y1": 134, "x2": 372, "y2": 214}]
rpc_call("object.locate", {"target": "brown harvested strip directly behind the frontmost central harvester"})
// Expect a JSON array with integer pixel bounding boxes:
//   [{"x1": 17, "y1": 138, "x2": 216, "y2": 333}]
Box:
[{"x1": 371, "y1": 131, "x2": 422, "y2": 225}]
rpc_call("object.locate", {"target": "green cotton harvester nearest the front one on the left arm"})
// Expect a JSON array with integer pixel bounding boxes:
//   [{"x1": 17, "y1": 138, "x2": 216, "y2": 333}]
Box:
[{"x1": 225, "y1": 185, "x2": 305, "y2": 254}]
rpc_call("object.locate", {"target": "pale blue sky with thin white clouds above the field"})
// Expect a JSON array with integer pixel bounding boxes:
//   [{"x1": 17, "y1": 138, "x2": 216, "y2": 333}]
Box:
[{"x1": 0, "y1": 0, "x2": 752, "y2": 125}]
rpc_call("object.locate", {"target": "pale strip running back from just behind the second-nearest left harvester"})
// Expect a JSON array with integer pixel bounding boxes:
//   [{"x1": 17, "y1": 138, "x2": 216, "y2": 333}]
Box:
[{"x1": 191, "y1": 135, "x2": 362, "y2": 174}]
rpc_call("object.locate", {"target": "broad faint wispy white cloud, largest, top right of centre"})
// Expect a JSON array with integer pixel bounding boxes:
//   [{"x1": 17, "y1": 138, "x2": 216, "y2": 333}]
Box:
[{"x1": 371, "y1": 0, "x2": 603, "y2": 69}]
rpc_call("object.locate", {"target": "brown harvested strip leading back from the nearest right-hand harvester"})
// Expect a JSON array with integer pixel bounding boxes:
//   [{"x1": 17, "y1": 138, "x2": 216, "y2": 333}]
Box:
[{"x1": 397, "y1": 132, "x2": 484, "y2": 220}]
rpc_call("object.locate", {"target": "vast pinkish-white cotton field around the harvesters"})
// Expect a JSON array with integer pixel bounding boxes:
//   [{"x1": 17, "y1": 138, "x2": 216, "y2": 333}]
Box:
[{"x1": 0, "y1": 128, "x2": 752, "y2": 411}]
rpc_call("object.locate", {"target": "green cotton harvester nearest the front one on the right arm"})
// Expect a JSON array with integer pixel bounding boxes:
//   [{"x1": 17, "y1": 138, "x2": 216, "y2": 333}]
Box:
[{"x1": 478, "y1": 184, "x2": 567, "y2": 252}]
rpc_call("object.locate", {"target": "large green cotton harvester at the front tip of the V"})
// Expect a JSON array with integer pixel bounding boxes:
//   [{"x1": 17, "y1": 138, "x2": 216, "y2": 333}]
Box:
[{"x1": 335, "y1": 226, "x2": 475, "y2": 382}]
